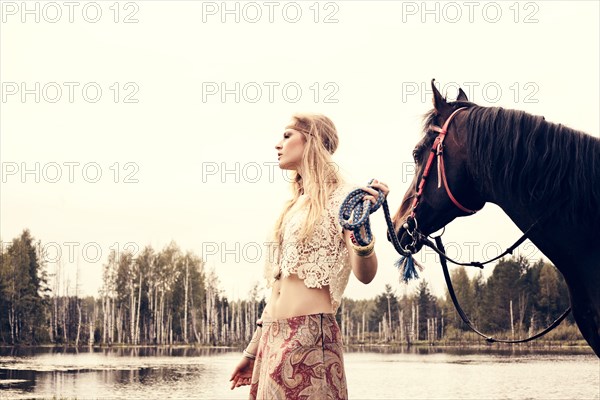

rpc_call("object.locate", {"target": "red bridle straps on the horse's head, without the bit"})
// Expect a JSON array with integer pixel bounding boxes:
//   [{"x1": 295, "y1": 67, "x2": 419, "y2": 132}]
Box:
[{"x1": 410, "y1": 107, "x2": 479, "y2": 219}]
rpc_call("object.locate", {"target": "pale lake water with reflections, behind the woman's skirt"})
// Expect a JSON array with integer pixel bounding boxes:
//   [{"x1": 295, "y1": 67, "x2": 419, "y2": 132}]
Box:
[{"x1": 0, "y1": 346, "x2": 600, "y2": 399}]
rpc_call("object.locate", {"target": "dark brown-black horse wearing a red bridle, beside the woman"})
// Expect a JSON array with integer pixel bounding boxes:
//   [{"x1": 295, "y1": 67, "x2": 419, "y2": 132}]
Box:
[{"x1": 388, "y1": 80, "x2": 600, "y2": 357}]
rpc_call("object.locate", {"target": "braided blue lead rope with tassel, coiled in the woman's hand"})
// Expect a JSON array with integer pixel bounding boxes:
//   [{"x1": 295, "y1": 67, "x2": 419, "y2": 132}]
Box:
[{"x1": 340, "y1": 180, "x2": 423, "y2": 283}]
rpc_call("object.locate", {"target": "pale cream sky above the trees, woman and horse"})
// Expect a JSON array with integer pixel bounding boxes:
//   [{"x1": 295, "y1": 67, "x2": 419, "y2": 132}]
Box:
[{"x1": 0, "y1": 1, "x2": 600, "y2": 299}]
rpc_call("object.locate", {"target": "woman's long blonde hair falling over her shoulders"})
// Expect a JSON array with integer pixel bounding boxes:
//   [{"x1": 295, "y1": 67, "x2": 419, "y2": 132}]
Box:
[{"x1": 273, "y1": 114, "x2": 344, "y2": 245}]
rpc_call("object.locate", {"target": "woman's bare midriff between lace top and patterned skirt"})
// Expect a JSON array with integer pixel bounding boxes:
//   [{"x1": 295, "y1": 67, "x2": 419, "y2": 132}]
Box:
[{"x1": 265, "y1": 274, "x2": 333, "y2": 319}]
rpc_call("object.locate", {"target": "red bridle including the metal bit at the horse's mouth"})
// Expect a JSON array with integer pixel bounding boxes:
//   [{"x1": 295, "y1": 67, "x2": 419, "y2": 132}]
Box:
[{"x1": 403, "y1": 107, "x2": 479, "y2": 253}]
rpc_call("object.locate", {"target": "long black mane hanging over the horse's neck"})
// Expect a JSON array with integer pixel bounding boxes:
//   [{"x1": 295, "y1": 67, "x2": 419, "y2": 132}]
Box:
[{"x1": 425, "y1": 102, "x2": 600, "y2": 222}]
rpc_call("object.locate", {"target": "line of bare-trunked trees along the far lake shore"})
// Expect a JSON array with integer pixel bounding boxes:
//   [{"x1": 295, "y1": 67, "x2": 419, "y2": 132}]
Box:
[{"x1": 0, "y1": 230, "x2": 581, "y2": 346}]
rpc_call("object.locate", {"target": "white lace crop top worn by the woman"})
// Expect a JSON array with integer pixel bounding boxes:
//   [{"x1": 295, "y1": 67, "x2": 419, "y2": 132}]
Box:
[{"x1": 264, "y1": 184, "x2": 358, "y2": 313}]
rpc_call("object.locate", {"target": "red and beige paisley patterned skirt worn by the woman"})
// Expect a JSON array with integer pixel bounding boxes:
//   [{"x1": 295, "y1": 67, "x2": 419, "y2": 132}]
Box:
[{"x1": 250, "y1": 314, "x2": 348, "y2": 400}]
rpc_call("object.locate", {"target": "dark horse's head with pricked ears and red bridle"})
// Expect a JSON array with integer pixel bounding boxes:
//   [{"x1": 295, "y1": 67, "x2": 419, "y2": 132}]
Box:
[{"x1": 393, "y1": 80, "x2": 485, "y2": 253}]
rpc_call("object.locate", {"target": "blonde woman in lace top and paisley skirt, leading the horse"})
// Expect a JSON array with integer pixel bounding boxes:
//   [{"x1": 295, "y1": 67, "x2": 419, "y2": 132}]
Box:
[{"x1": 230, "y1": 115, "x2": 389, "y2": 399}]
